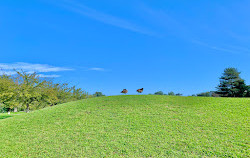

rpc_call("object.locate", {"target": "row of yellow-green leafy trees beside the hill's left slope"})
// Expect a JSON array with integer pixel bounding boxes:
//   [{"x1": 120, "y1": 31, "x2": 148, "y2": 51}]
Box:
[{"x1": 0, "y1": 71, "x2": 103, "y2": 112}]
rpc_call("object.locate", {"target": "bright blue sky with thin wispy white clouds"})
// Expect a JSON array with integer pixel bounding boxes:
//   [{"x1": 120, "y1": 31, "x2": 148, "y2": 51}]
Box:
[{"x1": 0, "y1": 0, "x2": 250, "y2": 95}]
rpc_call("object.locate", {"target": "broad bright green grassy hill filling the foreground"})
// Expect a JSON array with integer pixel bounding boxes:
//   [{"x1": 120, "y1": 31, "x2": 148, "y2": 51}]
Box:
[{"x1": 0, "y1": 95, "x2": 250, "y2": 157}]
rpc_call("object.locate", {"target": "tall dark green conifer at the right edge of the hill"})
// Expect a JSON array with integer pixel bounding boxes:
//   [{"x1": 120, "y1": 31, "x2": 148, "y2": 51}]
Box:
[{"x1": 216, "y1": 68, "x2": 247, "y2": 97}]
